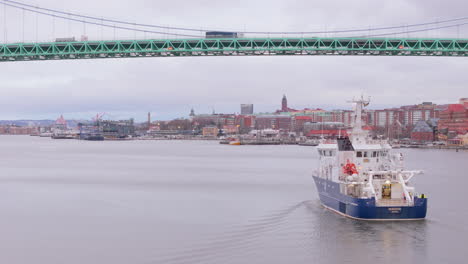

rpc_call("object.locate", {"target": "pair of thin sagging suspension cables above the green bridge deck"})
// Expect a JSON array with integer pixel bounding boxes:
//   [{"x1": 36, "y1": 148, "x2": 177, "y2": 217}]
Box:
[{"x1": 0, "y1": 0, "x2": 468, "y2": 37}]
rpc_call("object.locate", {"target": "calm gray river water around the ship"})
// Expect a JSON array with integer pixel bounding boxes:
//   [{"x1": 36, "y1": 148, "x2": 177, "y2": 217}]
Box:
[{"x1": 0, "y1": 136, "x2": 468, "y2": 264}]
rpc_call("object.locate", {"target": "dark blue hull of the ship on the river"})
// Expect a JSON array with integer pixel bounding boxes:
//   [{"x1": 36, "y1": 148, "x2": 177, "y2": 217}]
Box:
[{"x1": 313, "y1": 176, "x2": 427, "y2": 220}]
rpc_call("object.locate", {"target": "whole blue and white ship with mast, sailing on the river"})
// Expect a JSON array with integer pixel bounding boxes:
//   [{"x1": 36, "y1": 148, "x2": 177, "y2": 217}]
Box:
[{"x1": 313, "y1": 97, "x2": 427, "y2": 220}]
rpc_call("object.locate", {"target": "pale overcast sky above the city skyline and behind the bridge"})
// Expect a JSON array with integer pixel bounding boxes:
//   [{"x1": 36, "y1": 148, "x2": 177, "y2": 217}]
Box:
[{"x1": 0, "y1": 0, "x2": 468, "y2": 120}]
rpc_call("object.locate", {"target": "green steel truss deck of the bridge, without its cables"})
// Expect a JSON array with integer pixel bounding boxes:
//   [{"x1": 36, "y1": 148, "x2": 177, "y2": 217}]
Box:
[{"x1": 0, "y1": 38, "x2": 468, "y2": 62}]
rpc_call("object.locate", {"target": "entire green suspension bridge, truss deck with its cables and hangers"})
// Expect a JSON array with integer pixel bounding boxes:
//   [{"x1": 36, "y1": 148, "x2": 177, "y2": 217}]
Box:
[{"x1": 0, "y1": 0, "x2": 468, "y2": 62}]
